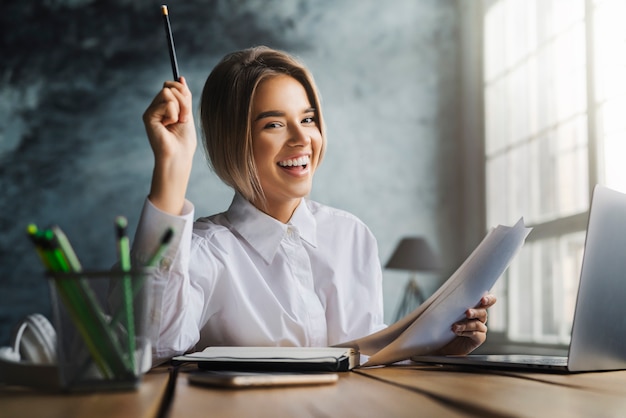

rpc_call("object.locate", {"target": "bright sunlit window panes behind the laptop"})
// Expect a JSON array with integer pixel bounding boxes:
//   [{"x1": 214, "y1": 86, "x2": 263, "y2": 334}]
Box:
[{"x1": 482, "y1": 0, "x2": 626, "y2": 344}]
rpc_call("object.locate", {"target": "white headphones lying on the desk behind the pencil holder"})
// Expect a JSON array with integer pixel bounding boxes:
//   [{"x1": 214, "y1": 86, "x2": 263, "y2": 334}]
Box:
[{"x1": 0, "y1": 313, "x2": 59, "y2": 389}]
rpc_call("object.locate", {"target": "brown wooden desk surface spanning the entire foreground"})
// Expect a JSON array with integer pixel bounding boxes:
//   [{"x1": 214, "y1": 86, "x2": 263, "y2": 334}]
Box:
[{"x1": 0, "y1": 366, "x2": 626, "y2": 418}]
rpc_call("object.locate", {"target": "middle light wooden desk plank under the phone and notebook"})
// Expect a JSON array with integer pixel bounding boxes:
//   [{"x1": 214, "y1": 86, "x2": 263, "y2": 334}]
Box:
[{"x1": 170, "y1": 372, "x2": 465, "y2": 418}]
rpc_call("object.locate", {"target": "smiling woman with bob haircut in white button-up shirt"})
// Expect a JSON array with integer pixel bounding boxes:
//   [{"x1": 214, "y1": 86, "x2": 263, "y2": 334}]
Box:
[{"x1": 133, "y1": 47, "x2": 495, "y2": 359}]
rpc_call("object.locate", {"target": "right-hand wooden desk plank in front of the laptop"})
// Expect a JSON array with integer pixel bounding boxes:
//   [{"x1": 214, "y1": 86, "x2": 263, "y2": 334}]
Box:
[{"x1": 358, "y1": 366, "x2": 626, "y2": 418}]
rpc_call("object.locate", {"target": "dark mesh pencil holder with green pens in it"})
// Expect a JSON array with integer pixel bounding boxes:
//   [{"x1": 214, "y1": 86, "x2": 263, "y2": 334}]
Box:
[{"x1": 49, "y1": 269, "x2": 154, "y2": 392}]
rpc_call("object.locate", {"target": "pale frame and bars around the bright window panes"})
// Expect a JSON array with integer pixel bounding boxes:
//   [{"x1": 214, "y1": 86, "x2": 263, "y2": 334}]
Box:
[{"x1": 458, "y1": 0, "x2": 603, "y2": 352}]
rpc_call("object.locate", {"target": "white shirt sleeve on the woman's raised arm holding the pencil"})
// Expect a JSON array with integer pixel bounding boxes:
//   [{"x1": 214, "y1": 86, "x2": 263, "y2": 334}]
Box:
[{"x1": 132, "y1": 199, "x2": 201, "y2": 364}]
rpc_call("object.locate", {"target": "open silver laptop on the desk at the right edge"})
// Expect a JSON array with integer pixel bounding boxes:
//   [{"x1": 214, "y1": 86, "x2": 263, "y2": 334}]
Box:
[{"x1": 411, "y1": 185, "x2": 626, "y2": 373}]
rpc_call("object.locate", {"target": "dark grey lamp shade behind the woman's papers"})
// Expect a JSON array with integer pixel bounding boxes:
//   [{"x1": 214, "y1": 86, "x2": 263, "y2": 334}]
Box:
[{"x1": 385, "y1": 237, "x2": 441, "y2": 271}]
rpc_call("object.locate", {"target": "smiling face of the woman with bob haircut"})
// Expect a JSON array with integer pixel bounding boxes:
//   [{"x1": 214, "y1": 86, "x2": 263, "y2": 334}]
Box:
[{"x1": 251, "y1": 75, "x2": 322, "y2": 222}]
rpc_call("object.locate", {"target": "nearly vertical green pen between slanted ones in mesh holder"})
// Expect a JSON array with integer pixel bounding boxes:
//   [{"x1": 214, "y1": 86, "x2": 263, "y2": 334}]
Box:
[{"x1": 115, "y1": 216, "x2": 135, "y2": 370}]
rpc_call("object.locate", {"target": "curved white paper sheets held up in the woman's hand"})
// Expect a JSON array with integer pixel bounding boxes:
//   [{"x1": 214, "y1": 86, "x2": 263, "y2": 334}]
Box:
[{"x1": 338, "y1": 218, "x2": 531, "y2": 366}]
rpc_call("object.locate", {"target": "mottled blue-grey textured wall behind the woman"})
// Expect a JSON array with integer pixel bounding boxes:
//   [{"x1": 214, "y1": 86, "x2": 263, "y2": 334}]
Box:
[{"x1": 0, "y1": 0, "x2": 461, "y2": 344}]
